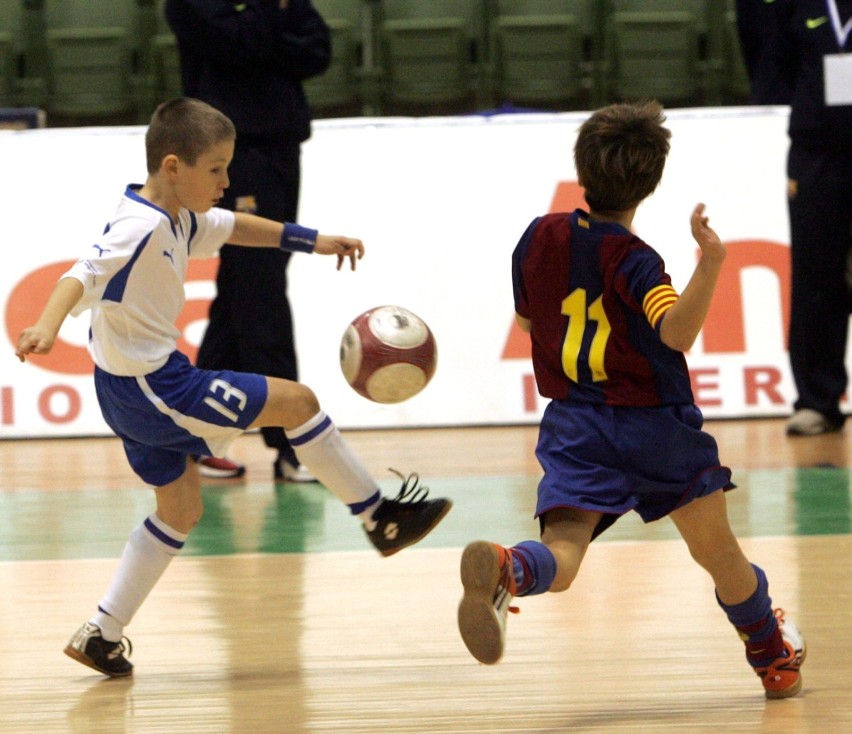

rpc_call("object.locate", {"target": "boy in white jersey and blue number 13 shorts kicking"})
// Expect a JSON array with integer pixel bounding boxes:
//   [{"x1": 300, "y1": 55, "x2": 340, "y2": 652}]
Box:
[{"x1": 16, "y1": 98, "x2": 451, "y2": 677}]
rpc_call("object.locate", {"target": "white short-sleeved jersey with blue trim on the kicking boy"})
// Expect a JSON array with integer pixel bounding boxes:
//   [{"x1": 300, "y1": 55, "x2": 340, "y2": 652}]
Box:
[{"x1": 63, "y1": 184, "x2": 234, "y2": 376}]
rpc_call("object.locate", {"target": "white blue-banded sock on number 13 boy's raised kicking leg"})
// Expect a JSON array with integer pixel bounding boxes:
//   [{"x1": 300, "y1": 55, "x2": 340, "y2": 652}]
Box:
[{"x1": 285, "y1": 410, "x2": 382, "y2": 530}]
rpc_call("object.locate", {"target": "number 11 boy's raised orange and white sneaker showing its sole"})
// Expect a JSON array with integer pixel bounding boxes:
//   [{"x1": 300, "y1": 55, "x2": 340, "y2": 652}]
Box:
[{"x1": 459, "y1": 540, "x2": 518, "y2": 665}]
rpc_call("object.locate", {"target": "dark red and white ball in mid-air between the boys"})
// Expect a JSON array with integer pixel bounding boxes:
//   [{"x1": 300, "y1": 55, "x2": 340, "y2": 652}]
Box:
[{"x1": 340, "y1": 306, "x2": 438, "y2": 403}]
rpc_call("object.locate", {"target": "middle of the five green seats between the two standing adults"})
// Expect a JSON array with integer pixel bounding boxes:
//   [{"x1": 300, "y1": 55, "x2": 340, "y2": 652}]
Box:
[{"x1": 491, "y1": 0, "x2": 594, "y2": 108}]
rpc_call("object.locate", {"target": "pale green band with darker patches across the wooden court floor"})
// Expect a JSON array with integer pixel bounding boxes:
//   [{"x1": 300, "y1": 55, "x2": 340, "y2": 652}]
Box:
[{"x1": 0, "y1": 468, "x2": 852, "y2": 561}]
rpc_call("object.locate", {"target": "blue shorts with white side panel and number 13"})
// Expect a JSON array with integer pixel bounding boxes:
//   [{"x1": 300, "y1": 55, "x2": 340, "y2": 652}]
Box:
[{"x1": 95, "y1": 352, "x2": 267, "y2": 487}]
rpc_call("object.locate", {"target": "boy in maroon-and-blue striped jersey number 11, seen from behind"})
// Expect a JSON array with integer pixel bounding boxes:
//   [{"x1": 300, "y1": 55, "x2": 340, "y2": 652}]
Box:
[{"x1": 458, "y1": 102, "x2": 805, "y2": 698}]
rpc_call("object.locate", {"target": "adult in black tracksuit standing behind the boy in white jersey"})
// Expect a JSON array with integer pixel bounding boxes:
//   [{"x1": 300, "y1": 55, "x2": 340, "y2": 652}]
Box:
[{"x1": 165, "y1": 0, "x2": 331, "y2": 481}]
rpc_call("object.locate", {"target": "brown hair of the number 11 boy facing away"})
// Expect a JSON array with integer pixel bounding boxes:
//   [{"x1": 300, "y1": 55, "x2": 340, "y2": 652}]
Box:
[{"x1": 574, "y1": 101, "x2": 671, "y2": 213}]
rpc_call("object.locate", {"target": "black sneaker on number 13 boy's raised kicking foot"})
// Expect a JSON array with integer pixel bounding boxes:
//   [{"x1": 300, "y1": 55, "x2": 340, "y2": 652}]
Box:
[{"x1": 364, "y1": 469, "x2": 453, "y2": 557}]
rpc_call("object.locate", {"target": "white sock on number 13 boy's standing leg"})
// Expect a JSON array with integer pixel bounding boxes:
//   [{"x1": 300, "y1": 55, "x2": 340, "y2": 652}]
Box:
[{"x1": 90, "y1": 514, "x2": 188, "y2": 642}]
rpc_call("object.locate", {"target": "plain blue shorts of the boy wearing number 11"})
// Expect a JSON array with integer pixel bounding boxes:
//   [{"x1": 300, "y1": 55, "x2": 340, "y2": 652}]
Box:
[{"x1": 536, "y1": 400, "x2": 734, "y2": 537}]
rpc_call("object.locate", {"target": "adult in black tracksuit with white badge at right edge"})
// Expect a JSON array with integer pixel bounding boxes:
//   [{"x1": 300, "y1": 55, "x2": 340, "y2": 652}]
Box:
[{"x1": 753, "y1": 0, "x2": 852, "y2": 435}]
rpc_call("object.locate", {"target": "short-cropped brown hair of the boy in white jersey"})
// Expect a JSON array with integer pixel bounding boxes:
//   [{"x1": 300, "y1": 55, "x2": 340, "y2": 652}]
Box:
[{"x1": 145, "y1": 97, "x2": 237, "y2": 173}]
